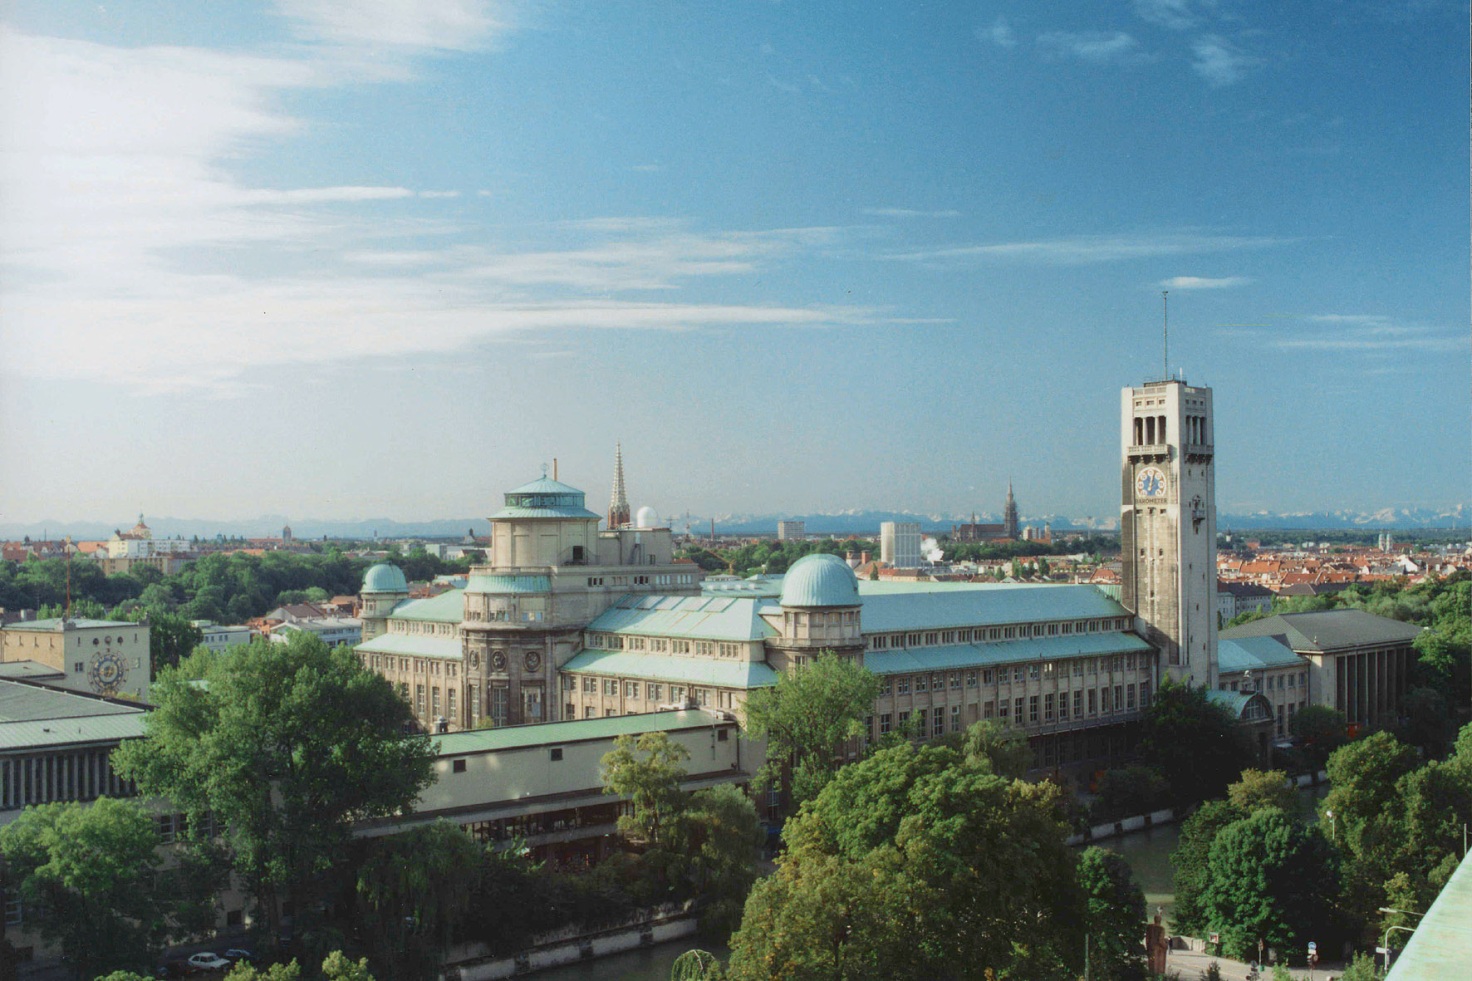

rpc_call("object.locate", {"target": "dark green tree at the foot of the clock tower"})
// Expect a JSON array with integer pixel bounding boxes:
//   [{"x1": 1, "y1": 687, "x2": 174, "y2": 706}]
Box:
[{"x1": 1139, "y1": 681, "x2": 1256, "y2": 806}]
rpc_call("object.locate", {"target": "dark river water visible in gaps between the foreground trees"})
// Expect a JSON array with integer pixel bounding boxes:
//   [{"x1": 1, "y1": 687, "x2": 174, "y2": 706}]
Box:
[{"x1": 531, "y1": 784, "x2": 1329, "y2": 981}]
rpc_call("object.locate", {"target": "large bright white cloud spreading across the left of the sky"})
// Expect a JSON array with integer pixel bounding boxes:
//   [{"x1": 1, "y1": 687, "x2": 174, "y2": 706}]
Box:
[{"x1": 0, "y1": 22, "x2": 886, "y2": 396}]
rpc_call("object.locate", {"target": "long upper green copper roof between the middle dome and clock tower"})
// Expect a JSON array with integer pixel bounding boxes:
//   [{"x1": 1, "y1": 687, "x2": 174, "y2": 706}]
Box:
[{"x1": 858, "y1": 580, "x2": 1130, "y2": 633}]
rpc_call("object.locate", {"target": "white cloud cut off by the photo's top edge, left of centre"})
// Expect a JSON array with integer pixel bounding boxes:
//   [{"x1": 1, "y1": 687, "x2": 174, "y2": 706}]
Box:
[{"x1": 275, "y1": 0, "x2": 506, "y2": 52}]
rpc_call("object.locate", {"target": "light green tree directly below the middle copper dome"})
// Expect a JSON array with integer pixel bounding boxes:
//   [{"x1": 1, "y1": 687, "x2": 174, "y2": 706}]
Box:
[{"x1": 746, "y1": 651, "x2": 879, "y2": 812}]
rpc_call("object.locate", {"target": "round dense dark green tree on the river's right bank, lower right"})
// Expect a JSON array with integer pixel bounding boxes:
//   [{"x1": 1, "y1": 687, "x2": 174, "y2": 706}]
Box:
[{"x1": 1201, "y1": 809, "x2": 1338, "y2": 960}]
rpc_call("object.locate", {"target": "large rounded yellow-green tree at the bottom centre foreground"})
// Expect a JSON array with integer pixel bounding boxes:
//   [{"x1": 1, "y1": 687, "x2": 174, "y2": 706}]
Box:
[{"x1": 729, "y1": 742, "x2": 1083, "y2": 980}]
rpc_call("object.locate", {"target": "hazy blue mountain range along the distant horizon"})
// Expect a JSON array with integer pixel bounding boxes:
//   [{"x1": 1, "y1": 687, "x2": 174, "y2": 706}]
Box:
[{"x1": 0, "y1": 504, "x2": 1472, "y2": 541}]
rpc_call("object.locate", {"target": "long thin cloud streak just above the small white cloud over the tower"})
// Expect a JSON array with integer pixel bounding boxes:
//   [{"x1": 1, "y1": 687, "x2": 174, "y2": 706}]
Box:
[{"x1": 889, "y1": 233, "x2": 1291, "y2": 265}]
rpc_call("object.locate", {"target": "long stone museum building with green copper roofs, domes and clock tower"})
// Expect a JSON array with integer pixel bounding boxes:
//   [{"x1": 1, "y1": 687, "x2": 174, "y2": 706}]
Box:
[{"x1": 356, "y1": 372, "x2": 1413, "y2": 770}]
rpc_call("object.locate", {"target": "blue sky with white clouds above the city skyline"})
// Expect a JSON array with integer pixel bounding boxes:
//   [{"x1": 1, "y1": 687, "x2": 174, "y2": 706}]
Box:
[{"x1": 0, "y1": 0, "x2": 1472, "y2": 521}]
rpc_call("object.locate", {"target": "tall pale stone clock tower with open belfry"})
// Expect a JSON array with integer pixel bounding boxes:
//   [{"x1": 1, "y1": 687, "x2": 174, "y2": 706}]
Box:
[{"x1": 1119, "y1": 379, "x2": 1216, "y2": 688}]
